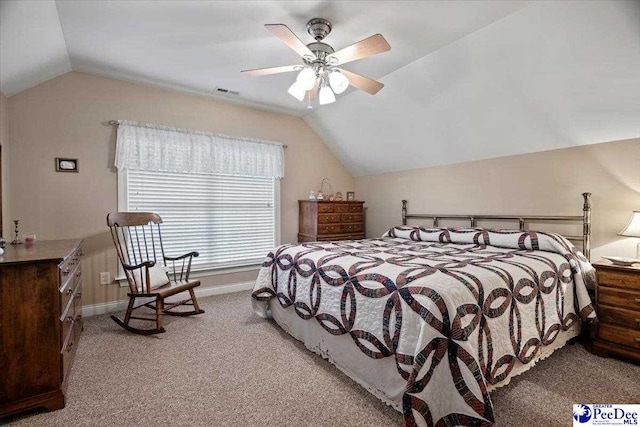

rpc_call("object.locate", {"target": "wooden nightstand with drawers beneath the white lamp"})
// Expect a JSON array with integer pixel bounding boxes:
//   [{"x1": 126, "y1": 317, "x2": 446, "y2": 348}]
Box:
[{"x1": 593, "y1": 260, "x2": 640, "y2": 362}]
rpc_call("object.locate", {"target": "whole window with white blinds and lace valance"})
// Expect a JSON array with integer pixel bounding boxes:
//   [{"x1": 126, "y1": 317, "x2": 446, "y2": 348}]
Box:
[{"x1": 115, "y1": 121, "x2": 285, "y2": 271}]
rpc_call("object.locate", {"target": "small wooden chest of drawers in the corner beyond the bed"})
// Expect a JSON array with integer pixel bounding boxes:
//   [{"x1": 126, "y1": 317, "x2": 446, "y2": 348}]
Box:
[{"x1": 298, "y1": 200, "x2": 364, "y2": 242}]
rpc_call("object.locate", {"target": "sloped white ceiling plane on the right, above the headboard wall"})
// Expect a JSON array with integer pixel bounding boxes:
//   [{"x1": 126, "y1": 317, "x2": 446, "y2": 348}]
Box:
[{"x1": 305, "y1": 1, "x2": 640, "y2": 175}]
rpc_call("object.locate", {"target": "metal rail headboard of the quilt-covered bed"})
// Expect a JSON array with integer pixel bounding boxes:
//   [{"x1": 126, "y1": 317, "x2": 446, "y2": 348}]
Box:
[{"x1": 402, "y1": 193, "x2": 591, "y2": 259}]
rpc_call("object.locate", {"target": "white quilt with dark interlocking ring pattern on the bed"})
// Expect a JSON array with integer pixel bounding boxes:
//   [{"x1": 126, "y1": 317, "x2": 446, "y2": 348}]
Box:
[{"x1": 252, "y1": 226, "x2": 595, "y2": 426}]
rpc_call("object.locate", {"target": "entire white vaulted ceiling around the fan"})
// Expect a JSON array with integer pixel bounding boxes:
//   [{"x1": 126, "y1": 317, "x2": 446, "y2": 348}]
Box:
[{"x1": 0, "y1": 0, "x2": 640, "y2": 175}]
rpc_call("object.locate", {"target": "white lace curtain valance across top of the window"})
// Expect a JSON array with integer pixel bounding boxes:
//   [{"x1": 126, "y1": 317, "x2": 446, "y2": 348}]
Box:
[{"x1": 115, "y1": 120, "x2": 284, "y2": 178}]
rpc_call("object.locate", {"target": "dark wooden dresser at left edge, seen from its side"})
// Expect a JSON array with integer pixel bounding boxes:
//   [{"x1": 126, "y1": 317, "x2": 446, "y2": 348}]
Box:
[{"x1": 0, "y1": 240, "x2": 82, "y2": 420}]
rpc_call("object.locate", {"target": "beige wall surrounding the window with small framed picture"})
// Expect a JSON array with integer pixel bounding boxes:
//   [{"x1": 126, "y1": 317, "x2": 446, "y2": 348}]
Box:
[{"x1": 8, "y1": 72, "x2": 354, "y2": 305}]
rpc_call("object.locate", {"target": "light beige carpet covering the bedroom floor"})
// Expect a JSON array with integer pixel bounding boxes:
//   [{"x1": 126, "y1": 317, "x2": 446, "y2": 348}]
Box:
[{"x1": 5, "y1": 292, "x2": 640, "y2": 426}]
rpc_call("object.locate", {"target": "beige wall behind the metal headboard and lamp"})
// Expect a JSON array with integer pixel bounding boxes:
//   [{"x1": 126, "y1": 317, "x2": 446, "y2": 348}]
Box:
[{"x1": 356, "y1": 139, "x2": 640, "y2": 260}]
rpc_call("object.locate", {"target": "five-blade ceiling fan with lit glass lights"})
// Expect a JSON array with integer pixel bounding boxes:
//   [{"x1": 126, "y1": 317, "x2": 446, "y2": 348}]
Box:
[{"x1": 242, "y1": 18, "x2": 391, "y2": 108}]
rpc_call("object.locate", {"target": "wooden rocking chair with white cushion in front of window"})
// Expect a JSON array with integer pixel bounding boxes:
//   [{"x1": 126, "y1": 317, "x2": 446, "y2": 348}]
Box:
[{"x1": 107, "y1": 212, "x2": 204, "y2": 335}]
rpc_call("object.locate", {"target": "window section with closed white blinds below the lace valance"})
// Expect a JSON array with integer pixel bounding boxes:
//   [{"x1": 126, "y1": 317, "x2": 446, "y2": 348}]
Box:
[{"x1": 119, "y1": 170, "x2": 279, "y2": 271}]
